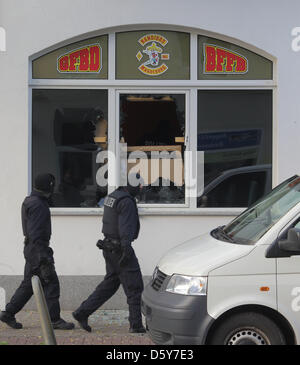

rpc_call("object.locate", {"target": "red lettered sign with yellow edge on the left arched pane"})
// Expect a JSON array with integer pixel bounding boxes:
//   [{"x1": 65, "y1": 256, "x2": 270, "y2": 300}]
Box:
[{"x1": 57, "y1": 44, "x2": 102, "y2": 73}]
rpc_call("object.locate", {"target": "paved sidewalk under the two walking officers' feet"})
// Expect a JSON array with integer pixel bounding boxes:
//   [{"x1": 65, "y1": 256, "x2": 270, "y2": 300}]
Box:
[{"x1": 0, "y1": 310, "x2": 153, "y2": 345}]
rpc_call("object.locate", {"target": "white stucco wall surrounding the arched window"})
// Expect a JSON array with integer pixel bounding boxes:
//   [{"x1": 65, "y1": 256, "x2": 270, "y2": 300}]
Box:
[{"x1": 0, "y1": 0, "x2": 300, "y2": 275}]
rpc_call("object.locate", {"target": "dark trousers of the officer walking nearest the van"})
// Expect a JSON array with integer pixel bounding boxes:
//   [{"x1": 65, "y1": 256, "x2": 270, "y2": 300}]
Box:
[{"x1": 76, "y1": 250, "x2": 144, "y2": 328}]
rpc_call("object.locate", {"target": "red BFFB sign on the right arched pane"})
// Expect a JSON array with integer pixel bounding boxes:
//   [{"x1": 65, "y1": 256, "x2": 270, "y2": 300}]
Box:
[{"x1": 204, "y1": 44, "x2": 248, "y2": 74}]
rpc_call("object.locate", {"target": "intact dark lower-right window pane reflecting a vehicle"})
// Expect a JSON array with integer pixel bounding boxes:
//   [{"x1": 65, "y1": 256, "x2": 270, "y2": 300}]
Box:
[{"x1": 198, "y1": 90, "x2": 272, "y2": 207}]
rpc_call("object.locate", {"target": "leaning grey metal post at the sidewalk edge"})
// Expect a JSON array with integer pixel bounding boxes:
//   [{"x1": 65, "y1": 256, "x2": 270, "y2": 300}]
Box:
[{"x1": 31, "y1": 276, "x2": 57, "y2": 345}]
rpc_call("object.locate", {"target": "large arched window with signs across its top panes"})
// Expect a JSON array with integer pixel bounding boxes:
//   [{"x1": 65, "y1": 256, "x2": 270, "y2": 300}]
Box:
[{"x1": 30, "y1": 26, "x2": 276, "y2": 211}]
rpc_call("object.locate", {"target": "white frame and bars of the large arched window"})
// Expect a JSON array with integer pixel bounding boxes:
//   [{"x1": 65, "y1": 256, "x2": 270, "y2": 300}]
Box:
[{"x1": 28, "y1": 25, "x2": 278, "y2": 216}]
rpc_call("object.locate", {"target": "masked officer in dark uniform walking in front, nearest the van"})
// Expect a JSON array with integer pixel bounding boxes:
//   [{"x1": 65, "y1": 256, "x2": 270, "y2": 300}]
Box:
[{"x1": 73, "y1": 179, "x2": 145, "y2": 333}]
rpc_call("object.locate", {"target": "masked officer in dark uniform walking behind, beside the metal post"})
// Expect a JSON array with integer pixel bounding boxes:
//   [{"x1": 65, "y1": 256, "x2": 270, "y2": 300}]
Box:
[{"x1": 0, "y1": 174, "x2": 74, "y2": 330}]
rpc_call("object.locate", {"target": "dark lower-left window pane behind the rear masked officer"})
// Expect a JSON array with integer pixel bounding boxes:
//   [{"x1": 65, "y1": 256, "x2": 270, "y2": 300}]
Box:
[{"x1": 32, "y1": 89, "x2": 108, "y2": 207}]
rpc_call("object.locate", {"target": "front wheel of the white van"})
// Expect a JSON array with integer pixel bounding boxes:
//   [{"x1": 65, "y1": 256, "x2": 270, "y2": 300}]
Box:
[{"x1": 209, "y1": 312, "x2": 286, "y2": 345}]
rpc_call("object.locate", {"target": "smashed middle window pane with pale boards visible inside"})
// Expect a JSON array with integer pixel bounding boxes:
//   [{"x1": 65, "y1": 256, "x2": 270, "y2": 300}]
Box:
[{"x1": 120, "y1": 94, "x2": 185, "y2": 204}]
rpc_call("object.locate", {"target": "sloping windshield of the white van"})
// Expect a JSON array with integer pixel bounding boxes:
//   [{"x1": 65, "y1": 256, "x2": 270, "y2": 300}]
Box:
[{"x1": 218, "y1": 176, "x2": 300, "y2": 244}]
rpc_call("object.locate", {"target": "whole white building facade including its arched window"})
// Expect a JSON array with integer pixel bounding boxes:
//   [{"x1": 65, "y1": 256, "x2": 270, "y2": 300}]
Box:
[{"x1": 0, "y1": 0, "x2": 300, "y2": 309}]
